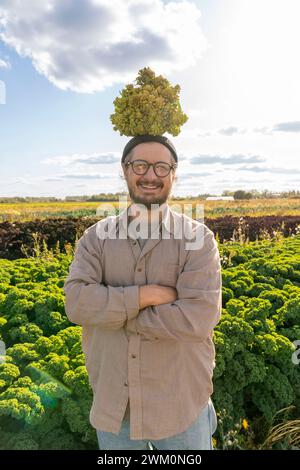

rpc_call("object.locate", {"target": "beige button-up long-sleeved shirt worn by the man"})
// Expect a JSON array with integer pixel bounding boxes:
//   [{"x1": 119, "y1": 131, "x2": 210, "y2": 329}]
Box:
[{"x1": 64, "y1": 203, "x2": 222, "y2": 440}]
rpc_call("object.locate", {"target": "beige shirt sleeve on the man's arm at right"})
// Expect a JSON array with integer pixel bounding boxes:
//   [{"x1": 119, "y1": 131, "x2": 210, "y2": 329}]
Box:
[{"x1": 127, "y1": 228, "x2": 222, "y2": 341}]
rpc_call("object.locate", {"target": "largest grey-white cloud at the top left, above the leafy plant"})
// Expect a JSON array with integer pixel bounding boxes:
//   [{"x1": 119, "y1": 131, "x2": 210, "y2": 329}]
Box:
[{"x1": 0, "y1": 0, "x2": 207, "y2": 93}]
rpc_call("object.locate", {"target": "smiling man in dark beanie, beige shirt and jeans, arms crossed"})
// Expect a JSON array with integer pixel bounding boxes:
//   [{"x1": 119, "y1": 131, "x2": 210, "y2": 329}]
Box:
[{"x1": 64, "y1": 135, "x2": 221, "y2": 450}]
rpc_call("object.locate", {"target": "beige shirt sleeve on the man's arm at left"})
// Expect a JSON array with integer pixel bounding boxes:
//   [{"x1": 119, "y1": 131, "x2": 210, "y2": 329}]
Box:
[{"x1": 63, "y1": 229, "x2": 139, "y2": 330}]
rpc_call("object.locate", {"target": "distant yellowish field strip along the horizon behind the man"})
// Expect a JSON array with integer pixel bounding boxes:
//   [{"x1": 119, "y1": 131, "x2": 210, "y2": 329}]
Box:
[{"x1": 0, "y1": 198, "x2": 300, "y2": 222}]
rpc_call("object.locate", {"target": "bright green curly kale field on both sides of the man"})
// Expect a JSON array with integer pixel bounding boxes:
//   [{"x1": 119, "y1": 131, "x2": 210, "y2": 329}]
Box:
[{"x1": 0, "y1": 234, "x2": 300, "y2": 449}]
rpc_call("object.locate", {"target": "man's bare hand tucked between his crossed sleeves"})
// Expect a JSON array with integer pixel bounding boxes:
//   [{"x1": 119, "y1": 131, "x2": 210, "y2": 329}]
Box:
[{"x1": 139, "y1": 284, "x2": 178, "y2": 310}]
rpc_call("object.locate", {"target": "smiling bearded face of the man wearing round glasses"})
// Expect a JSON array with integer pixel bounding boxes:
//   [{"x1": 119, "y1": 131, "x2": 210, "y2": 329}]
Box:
[{"x1": 124, "y1": 142, "x2": 175, "y2": 209}]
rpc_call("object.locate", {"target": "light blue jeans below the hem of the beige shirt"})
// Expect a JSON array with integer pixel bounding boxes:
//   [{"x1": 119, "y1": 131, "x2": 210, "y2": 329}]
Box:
[{"x1": 97, "y1": 399, "x2": 217, "y2": 450}]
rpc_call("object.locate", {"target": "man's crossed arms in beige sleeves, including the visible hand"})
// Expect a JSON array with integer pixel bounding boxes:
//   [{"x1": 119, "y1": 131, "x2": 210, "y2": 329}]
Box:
[{"x1": 64, "y1": 225, "x2": 221, "y2": 341}]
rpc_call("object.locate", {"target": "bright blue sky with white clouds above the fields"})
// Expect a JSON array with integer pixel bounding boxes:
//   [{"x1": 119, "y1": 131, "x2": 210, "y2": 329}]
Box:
[{"x1": 0, "y1": 0, "x2": 300, "y2": 198}]
